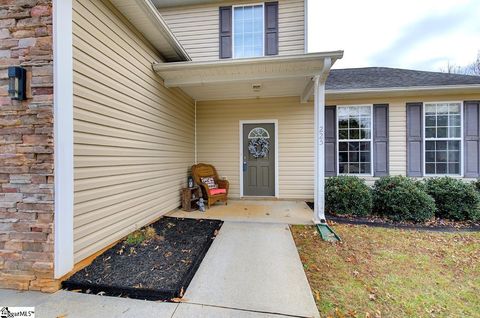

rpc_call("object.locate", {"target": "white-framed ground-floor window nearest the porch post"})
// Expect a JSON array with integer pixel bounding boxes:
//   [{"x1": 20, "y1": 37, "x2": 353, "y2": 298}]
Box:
[{"x1": 337, "y1": 105, "x2": 372, "y2": 175}]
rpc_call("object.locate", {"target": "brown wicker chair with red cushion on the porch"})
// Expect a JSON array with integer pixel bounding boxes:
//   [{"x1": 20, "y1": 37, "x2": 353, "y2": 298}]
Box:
[{"x1": 192, "y1": 163, "x2": 229, "y2": 208}]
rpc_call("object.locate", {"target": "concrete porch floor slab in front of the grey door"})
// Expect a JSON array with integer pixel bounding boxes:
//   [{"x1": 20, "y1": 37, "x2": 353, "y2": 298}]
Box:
[{"x1": 168, "y1": 199, "x2": 313, "y2": 224}]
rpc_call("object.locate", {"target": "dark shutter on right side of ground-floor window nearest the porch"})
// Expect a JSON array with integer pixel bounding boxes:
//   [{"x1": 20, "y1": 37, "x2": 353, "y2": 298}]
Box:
[{"x1": 373, "y1": 104, "x2": 388, "y2": 177}]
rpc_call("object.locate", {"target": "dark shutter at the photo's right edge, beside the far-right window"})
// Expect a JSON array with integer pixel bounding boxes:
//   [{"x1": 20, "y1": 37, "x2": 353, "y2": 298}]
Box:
[{"x1": 463, "y1": 101, "x2": 480, "y2": 178}]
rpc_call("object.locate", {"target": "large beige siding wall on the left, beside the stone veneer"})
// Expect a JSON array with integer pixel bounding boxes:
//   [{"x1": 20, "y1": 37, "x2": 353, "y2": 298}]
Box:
[{"x1": 73, "y1": 0, "x2": 194, "y2": 262}]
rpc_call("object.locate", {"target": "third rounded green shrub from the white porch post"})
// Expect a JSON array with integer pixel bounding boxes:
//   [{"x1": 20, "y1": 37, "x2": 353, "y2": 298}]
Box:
[{"x1": 425, "y1": 177, "x2": 480, "y2": 221}]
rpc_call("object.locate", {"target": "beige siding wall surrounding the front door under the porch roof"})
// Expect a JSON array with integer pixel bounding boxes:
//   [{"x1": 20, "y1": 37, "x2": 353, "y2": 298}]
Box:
[{"x1": 197, "y1": 97, "x2": 313, "y2": 199}]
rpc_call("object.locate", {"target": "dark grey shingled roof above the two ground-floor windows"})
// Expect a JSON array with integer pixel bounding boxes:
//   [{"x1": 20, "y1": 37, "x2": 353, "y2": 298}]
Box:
[{"x1": 326, "y1": 67, "x2": 480, "y2": 90}]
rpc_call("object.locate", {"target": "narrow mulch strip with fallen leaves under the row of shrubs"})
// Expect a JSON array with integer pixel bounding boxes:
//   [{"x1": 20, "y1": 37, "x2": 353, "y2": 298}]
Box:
[{"x1": 306, "y1": 202, "x2": 480, "y2": 232}]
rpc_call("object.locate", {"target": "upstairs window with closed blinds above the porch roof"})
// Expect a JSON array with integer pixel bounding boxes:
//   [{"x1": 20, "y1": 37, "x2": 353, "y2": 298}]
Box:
[{"x1": 233, "y1": 4, "x2": 264, "y2": 58}]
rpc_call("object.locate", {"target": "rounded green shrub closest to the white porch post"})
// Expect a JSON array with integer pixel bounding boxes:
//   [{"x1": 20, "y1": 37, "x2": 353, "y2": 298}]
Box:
[{"x1": 325, "y1": 176, "x2": 372, "y2": 216}]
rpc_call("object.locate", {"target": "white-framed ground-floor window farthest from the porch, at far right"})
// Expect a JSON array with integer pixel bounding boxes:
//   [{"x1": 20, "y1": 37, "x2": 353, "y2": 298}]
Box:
[{"x1": 424, "y1": 102, "x2": 462, "y2": 175}]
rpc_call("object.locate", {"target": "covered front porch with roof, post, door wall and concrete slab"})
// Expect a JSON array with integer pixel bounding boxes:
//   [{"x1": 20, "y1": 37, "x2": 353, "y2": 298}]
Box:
[{"x1": 153, "y1": 51, "x2": 343, "y2": 224}]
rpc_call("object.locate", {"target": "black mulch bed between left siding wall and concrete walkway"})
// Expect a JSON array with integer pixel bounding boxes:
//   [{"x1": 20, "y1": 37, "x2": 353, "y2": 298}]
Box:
[{"x1": 63, "y1": 217, "x2": 223, "y2": 300}]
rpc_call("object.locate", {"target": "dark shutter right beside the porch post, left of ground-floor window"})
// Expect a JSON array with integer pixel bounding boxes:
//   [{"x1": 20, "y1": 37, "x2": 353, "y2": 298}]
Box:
[{"x1": 325, "y1": 106, "x2": 337, "y2": 177}]
